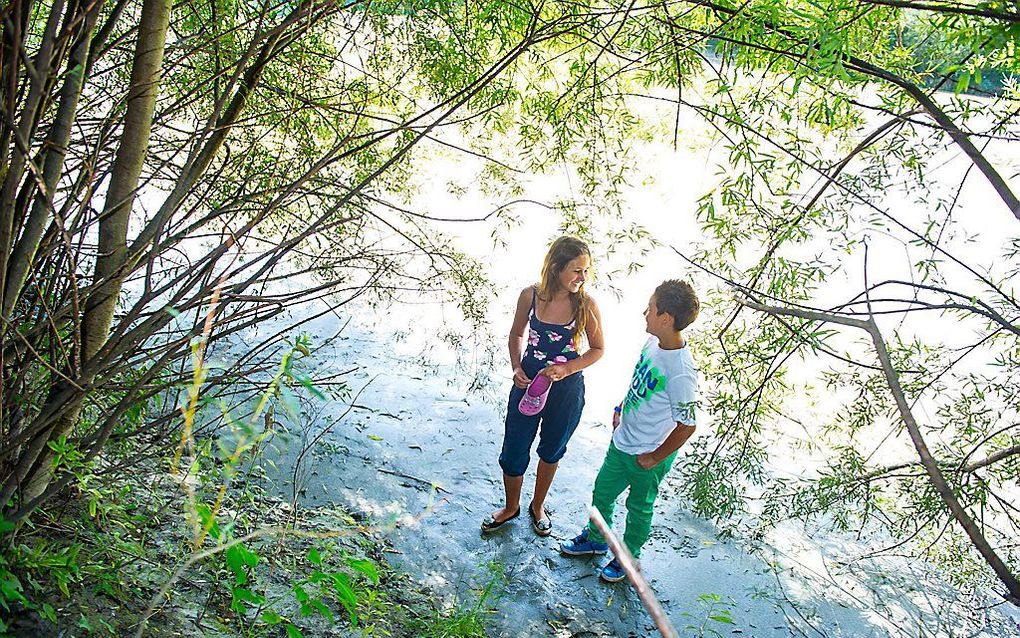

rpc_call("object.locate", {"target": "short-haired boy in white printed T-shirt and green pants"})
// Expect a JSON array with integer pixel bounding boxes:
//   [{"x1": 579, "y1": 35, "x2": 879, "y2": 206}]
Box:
[{"x1": 560, "y1": 280, "x2": 701, "y2": 583}]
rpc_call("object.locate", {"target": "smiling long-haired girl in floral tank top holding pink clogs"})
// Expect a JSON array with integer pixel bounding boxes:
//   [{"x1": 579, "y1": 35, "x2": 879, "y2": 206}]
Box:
[{"x1": 481, "y1": 237, "x2": 603, "y2": 536}]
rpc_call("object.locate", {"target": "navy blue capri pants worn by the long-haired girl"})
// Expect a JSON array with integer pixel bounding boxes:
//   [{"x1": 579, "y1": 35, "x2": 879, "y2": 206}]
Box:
[{"x1": 500, "y1": 373, "x2": 584, "y2": 477}]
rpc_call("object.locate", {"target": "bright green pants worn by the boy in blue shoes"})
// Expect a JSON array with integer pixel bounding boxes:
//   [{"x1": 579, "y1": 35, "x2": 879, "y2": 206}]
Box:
[{"x1": 588, "y1": 443, "x2": 676, "y2": 558}]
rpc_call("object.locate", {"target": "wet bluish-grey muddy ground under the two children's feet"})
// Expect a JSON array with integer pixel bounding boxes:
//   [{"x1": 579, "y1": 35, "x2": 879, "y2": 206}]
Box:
[{"x1": 257, "y1": 300, "x2": 1020, "y2": 638}]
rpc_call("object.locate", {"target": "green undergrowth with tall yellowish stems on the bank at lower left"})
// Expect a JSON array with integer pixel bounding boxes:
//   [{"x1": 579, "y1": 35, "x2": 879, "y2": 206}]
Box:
[{"x1": 0, "y1": 335, "x2": 502, "y2": 638}]
